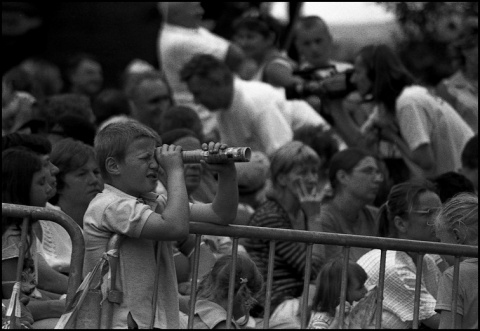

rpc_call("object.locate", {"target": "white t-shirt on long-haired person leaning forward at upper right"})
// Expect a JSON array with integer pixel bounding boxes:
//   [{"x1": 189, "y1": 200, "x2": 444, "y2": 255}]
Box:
[{"x1": 396, "y1": 86, "x2": 474, "y2": 176}]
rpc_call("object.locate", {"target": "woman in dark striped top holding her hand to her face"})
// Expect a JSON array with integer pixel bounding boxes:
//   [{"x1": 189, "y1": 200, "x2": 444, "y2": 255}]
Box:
[{"x1": 244, "y1": 141, "x2": 321, "y2": 327}]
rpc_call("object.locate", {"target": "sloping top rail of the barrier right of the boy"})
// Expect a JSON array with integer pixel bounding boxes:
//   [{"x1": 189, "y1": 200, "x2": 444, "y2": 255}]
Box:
[{"x1": 190, "y1": 222, "x2": 478, "y2": 257}]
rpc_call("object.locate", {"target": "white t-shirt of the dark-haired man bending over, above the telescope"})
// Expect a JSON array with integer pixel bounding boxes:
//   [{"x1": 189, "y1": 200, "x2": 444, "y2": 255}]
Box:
[{"x1": 215, "y1": 78, "x2": 293, "y2": 155}]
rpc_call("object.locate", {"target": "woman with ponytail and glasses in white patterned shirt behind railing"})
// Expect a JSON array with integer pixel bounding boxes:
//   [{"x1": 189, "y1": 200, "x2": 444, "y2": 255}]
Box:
[{"x1": 357, "y1": 182, "x2": 442, "y2": 329}]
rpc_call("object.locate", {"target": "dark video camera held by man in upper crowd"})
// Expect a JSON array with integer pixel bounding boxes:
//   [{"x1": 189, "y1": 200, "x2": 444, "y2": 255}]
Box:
[{"x1": 285, "y1": 65, "x2": 355, "y2": 99}]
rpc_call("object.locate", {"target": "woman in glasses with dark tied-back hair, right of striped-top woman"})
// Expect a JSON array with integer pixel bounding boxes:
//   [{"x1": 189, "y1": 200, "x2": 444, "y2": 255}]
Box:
[{"x1": 319, "y1": 148, "x2": 383, "y2": 262}]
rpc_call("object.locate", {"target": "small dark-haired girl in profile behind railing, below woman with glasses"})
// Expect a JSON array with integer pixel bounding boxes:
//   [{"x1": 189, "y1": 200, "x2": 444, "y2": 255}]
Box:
[{"x1": 308, "y1": 258, "x2": 368, "y2": 329}]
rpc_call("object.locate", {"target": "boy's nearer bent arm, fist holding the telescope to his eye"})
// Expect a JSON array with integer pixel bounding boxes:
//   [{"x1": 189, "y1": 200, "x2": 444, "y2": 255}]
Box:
[{"x1": 140, "y1": 145, "x2": 190, "y2": 241}]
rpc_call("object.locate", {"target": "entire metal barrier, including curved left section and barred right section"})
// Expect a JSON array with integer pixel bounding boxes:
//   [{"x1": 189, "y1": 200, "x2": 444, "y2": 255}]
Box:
[{"x1": 2, "y1": 203, "x2": 478, "y2": 329}]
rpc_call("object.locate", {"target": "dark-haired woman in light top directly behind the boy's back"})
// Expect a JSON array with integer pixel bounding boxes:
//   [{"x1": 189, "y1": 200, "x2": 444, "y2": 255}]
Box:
[{"x1": 34, "y1": 138, "x2": 103, "y2": 274}]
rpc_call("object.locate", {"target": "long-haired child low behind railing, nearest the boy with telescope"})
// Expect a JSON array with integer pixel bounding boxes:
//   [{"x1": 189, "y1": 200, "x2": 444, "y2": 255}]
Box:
[{"x1": 193, "y1": 253, "x2": 263, "y2": 329}]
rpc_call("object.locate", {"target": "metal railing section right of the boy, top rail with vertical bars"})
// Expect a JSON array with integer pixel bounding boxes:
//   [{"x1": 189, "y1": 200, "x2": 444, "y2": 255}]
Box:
[{"x1": 188, "y1": 222, "x2": 478, "y2": 329}]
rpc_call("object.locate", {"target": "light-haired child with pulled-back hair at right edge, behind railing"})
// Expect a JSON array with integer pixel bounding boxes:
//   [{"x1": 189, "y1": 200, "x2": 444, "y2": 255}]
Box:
[{"x1": 435, "y1": 193, "x2": 478, "y2": 329}]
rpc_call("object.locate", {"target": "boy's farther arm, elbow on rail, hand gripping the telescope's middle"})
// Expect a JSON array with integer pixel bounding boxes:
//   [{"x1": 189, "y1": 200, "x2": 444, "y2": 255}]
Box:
[{"x1": 190, "y1": 143, "x2": 238, "y2": 225}]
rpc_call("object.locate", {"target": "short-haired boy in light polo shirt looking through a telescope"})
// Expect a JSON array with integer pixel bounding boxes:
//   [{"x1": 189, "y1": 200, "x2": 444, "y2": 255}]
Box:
[{"x1": 83, "y1": 120, "x2": 238, "y2": 329}]
